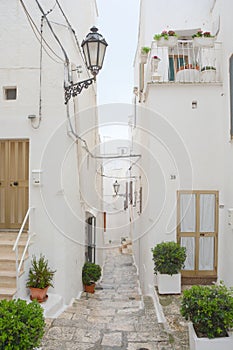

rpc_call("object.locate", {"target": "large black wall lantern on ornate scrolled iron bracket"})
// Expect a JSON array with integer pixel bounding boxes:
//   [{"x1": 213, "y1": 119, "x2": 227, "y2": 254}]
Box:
[{"x1": 65, "y1": 27, "x2": 108, "y2": 104}]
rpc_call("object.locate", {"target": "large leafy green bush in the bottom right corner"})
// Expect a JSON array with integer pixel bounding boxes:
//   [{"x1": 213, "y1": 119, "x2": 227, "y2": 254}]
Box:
[{"x1": 180, "y1": 282, "x2": 233, "y2": 338}]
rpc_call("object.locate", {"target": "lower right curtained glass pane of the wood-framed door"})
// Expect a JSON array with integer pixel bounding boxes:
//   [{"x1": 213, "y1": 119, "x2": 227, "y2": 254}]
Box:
[{"x1": 199, "y1": 237, "x2": 214, "y2": 270}]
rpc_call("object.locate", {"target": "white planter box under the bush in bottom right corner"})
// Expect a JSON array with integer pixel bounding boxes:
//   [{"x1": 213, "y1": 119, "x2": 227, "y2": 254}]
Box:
[{"x1": 188, "y1": 322, "x2": 233, "y2": 350}]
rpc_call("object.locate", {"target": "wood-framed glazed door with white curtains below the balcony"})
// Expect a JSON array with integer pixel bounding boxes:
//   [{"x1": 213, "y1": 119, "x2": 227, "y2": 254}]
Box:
[{"x1": 177, "y1": 191, "x2": 218, "y2": 280}]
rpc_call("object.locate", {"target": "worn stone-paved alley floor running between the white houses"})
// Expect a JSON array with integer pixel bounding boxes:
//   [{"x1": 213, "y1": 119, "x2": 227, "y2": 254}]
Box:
[{"x1": 42, "y1": 249, "x2": 188, "y2": 350}]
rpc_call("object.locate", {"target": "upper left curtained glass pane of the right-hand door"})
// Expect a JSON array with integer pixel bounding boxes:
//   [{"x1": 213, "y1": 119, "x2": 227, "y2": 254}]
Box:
[{"x1": 180, "y1": 194, "x2": 196, "y2": 232}]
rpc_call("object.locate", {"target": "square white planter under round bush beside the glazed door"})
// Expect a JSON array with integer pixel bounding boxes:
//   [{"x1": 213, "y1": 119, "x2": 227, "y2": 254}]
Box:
[{"x1": 157, "y1": 273, "x2": 181, "y2": 294}]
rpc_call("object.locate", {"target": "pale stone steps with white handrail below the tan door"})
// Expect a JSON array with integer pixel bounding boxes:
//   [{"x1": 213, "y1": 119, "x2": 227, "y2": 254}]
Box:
[{"x1": 0, "y1": 231, "x2": 28, "y2": 300}]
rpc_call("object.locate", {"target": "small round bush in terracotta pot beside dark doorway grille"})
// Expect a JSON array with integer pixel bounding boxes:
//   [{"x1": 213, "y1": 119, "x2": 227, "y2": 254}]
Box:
[{"x1": 82, "y1": 262, "x2": 101, "y2": 293}]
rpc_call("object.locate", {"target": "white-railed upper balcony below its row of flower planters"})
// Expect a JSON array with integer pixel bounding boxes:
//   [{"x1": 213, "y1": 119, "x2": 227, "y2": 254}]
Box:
[{"x1": 145, "y1": 40, "x2": 222, "y2": 84}]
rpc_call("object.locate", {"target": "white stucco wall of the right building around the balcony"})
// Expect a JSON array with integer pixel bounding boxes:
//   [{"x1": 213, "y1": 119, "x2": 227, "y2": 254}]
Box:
[{"x1": 134, "y1": 0, "x2": 233, "y2": 292}]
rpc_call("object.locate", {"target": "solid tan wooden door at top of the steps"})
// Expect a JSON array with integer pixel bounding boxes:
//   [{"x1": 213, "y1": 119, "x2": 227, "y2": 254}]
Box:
[{"x1": 0, "y1": 140, "x2": 29, "y2": 229}]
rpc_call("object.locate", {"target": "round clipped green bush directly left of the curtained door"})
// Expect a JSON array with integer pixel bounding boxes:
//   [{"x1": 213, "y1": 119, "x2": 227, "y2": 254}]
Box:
[{"x1": 151, "y1": 242, "x2": 186, "y2": 276}]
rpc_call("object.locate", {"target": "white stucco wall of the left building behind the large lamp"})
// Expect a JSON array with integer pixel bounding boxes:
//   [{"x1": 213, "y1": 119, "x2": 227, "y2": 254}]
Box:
[{"x1": 0, "y1": 0, "x2": 103, "y2": 303}]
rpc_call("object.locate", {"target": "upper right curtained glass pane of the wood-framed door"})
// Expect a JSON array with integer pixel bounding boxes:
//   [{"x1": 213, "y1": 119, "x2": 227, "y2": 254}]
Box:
[{"x1": 200, "y1": 194, "x2": 215, "y2": 232}]
